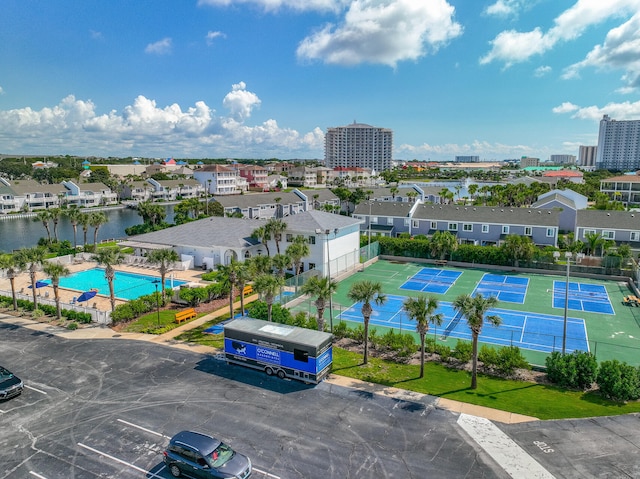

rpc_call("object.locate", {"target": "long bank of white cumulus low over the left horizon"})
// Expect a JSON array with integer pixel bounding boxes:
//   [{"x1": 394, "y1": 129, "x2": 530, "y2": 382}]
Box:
[{"x1": 0, "y1": 86, "x2": 324, "y2": 158}]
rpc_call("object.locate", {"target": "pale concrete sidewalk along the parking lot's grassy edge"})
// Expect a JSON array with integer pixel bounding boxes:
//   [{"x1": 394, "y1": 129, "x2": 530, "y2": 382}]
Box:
[{"x1": 0, "y1": 310, "x2": 538, "y2": 424}]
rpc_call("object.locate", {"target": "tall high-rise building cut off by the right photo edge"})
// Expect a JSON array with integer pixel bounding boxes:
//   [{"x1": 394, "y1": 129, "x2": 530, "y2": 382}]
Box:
[{"x1": 596, "y1": 115, "x2": 640, "y2": 171}]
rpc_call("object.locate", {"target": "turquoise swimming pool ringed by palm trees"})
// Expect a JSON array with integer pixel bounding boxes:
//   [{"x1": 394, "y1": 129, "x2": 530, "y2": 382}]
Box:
[{"x1": 52, "y1": 268, "x2": 187, "y2": 299}]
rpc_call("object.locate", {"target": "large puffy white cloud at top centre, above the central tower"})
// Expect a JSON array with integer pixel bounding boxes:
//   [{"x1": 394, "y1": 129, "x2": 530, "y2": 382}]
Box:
[{"x1": 297, "y1": 0, "x2": 462, "y2": 67}]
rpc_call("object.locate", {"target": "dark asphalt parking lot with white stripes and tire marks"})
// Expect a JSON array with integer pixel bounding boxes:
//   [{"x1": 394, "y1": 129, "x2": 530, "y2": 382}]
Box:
[{"x1": 0, "y1": 323, "x2": 507, "y2": 479}]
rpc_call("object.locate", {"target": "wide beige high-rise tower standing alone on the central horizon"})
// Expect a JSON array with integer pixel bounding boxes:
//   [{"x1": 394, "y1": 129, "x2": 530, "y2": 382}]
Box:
[{"x1": 324, "y1": 122, "x2": 393, "y2": 172}]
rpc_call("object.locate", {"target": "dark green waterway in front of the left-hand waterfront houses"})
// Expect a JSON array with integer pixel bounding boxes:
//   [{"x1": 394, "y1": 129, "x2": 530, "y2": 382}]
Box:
[{"x1": 0, "y1": 205, "x2": 173, "y2": 252}]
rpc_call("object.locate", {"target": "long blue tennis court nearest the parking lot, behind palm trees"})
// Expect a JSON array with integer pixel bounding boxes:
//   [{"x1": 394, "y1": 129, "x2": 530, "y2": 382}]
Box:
[{"x1": 338, "y1": 295, "x2": 589, "y2": 353}]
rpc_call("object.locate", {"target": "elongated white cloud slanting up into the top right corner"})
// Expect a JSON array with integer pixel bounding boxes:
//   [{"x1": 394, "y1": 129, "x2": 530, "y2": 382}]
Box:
[{"x1": 480, "y1": 0, "x2": 640, "y2": 67}]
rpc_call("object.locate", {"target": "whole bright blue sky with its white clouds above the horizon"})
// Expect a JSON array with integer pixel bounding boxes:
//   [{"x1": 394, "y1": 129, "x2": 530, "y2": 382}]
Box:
[{"x1": 0, "y1": 0, "x2": 640, "y2": 161}]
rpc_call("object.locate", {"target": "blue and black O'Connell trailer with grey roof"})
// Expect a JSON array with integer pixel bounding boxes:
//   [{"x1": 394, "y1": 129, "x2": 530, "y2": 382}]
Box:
[{"x1": 224, "y1": 318, "x2": 333, "y2": 384}]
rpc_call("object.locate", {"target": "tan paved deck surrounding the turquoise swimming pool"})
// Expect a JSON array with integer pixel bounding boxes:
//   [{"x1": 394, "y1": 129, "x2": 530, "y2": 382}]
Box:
[{"x1": 0, "y1": 261, "x2": 203, "y2": 311}]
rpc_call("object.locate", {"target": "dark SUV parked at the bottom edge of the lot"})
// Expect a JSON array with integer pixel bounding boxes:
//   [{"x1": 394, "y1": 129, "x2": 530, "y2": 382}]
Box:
[{"x1": 164, "y1": 431, "x2": 251, "y2": 479}]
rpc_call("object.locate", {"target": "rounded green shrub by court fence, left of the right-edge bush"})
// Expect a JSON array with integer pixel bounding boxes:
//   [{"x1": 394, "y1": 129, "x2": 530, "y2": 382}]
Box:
[{"x1": 545, "y1": 351, "x2": 598, "y2": 390}]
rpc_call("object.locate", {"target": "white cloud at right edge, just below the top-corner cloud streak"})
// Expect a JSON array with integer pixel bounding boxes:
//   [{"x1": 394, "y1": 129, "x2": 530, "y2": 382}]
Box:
[{"x1": 562, "y1": 13, "x2": 640, "y2": 93}]
